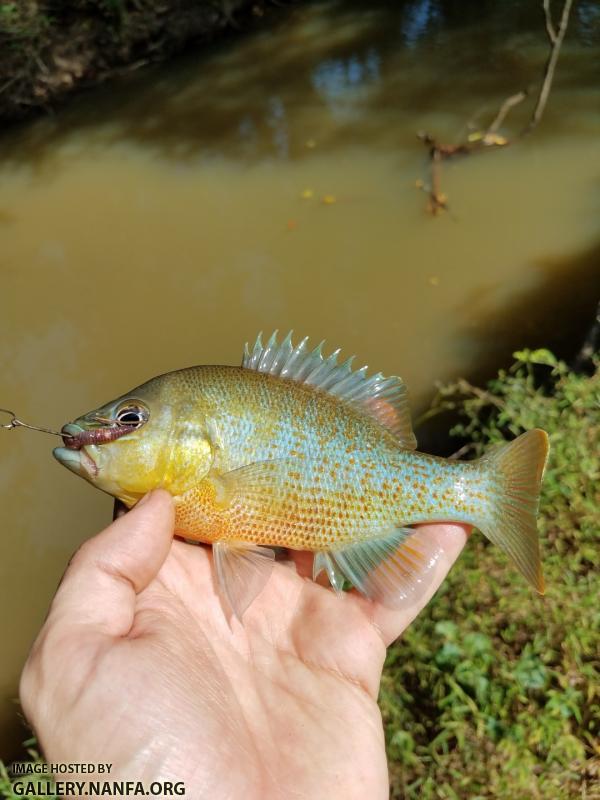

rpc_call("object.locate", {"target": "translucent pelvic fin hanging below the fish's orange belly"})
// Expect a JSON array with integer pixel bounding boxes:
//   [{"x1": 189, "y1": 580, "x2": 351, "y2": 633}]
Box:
[{"x1": 213, "y1": 542, "x2": 275, "y2": 621}]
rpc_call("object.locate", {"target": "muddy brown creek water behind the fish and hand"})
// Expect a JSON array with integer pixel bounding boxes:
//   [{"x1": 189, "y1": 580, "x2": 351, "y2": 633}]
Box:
[{"x1": 0, "y1": 0, "x2": 600, "y2": 756}]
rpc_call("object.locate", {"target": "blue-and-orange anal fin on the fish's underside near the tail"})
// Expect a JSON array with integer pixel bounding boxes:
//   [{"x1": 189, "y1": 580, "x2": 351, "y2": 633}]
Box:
[{"x1": 328, "y1": 527, "x2": 442, "y2": 608}]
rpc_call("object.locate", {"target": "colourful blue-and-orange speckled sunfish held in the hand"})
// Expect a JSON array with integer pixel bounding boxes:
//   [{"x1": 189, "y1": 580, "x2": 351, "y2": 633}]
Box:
[{"x1": 54, "y1": 331, "x2": 549, "y2": 620}]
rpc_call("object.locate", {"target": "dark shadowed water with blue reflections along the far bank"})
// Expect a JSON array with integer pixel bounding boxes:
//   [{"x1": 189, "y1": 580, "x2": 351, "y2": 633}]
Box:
[{"x1": 4, "y1": 0, "x2": 600, "y2": 168}]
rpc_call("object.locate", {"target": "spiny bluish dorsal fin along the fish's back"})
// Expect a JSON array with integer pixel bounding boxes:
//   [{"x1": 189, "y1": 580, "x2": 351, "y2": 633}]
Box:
[{"x1": 242, "y1": 331, "x2": 417, "y2": 450}]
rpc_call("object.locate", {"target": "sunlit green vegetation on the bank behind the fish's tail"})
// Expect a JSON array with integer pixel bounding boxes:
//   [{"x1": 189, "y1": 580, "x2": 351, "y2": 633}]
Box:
[{"x1": 380, "y1": 350, "x2": 600, "y2": 800}]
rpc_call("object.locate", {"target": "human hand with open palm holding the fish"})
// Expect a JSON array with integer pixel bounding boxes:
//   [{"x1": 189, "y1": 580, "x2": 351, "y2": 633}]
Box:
[{"x1": 21, "y1": 491, "x2": 467, "y2": 800}]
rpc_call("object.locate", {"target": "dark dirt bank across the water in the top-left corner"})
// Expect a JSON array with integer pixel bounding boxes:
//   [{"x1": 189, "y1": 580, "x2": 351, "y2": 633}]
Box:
[{"x1": 0, "y1": 0, "x2": 284, "y2": 121}]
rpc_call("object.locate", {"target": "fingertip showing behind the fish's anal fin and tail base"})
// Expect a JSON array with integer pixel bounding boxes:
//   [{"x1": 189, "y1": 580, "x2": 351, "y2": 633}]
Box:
[{"x1": 362, "y1": 523, "x2": 472, "y2": 646}]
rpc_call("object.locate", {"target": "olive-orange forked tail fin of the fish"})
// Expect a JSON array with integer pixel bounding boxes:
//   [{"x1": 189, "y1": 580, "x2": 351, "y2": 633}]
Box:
[{"x1": 481, "y1": 428, "x2": 549, "y2": 594}]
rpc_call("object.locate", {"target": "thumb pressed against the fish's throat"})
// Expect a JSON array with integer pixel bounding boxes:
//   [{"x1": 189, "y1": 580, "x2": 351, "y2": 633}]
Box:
[{"x1": 48, "y1": 491, "x2": 174, "y2": 636}]
